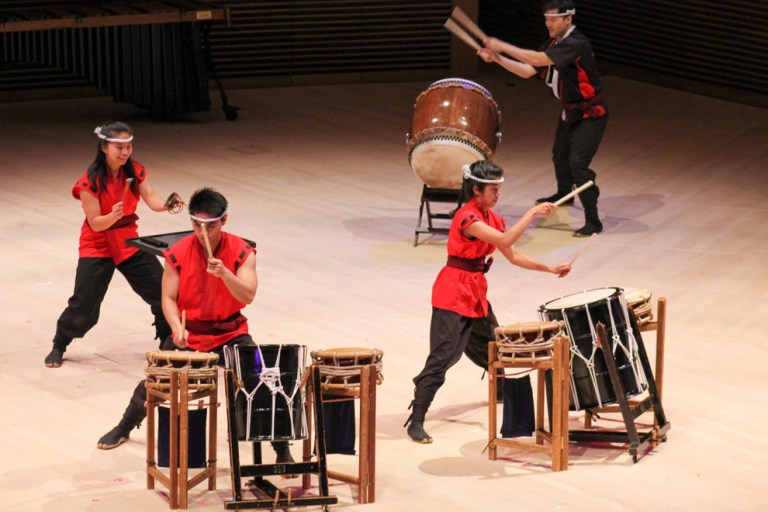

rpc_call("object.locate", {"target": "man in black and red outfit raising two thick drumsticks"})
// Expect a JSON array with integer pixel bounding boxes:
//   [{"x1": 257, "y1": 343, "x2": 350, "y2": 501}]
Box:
[{"x1": 478, "y1": 0, "x2": 608, "y2": 237}]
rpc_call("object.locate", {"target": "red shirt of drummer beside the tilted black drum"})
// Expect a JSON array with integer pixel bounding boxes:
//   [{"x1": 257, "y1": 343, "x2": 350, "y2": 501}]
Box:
[{"x1": 432, "y1": 199, "x2": 506, "y2": 318}]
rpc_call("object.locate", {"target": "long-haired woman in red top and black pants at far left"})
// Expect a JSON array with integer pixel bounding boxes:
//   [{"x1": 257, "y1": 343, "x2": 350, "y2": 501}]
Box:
[{"x1": 45, "y1": 121, "x2": 181, "y2": 368}]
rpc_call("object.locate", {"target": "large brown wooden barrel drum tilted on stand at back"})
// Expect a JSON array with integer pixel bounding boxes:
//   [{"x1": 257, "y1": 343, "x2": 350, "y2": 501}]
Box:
[{"x1": 406, "y1": 78, "x2": 501, "y2": 189}]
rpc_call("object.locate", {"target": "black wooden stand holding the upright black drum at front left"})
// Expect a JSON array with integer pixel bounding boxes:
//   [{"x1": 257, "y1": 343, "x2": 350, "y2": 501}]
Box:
[{"x1": 219, "y1": 366, "x2": 338, "y2": 510}]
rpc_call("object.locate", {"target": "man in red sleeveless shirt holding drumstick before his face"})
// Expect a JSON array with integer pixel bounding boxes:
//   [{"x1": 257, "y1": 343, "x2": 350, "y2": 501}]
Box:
[{"x1": 97, "y1": 188, "x2": 293, "y2": 463}]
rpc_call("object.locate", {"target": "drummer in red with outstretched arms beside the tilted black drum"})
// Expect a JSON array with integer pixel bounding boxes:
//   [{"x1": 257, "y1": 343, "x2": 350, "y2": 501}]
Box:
[{"x1": 406, "y1": 161, "x2": 571, "y2": 443}]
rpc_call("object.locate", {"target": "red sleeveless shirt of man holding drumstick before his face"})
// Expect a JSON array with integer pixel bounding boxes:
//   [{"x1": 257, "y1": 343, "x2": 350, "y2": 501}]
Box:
[{"x1": 163, "y1": 232, "x2": 256, "y2": 352}]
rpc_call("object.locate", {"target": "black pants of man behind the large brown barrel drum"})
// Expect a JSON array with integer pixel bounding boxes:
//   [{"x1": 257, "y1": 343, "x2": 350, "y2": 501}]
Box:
[{"x1": 552, "y1": 115, "x2": 608, "y2": 223}]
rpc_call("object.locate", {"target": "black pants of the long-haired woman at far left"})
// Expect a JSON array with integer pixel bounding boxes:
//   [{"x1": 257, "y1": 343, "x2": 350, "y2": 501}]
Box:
[{"x1": 54, "y1": 251, "x2": 171, "y2": 348}]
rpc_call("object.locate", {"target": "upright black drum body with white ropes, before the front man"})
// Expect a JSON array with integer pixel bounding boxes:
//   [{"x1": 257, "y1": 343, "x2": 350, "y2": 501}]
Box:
[{"x1": 228, "y1": 345, "x2": 307, "y2": 441}]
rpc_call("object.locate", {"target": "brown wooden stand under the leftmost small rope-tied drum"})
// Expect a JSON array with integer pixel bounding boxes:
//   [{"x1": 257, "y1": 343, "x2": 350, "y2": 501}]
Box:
[{"x1": 147, "y1": 367, "x2": 218, "y2": 509}]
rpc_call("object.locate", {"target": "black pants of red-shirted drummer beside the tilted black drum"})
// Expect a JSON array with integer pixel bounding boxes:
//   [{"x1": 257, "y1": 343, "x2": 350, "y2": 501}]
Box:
[{"x1": 413, "y1": 304, "x2": 499, "y2": 408}]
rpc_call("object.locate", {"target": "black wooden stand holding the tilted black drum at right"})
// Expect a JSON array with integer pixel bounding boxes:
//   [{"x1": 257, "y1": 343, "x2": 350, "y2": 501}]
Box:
[{"x1": 570, "y1": 317, "x2": 670, "y2": 462}]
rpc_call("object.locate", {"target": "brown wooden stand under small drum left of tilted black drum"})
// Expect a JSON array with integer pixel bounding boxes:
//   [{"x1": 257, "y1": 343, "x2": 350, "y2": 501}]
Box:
[{"x1": 488, "y1": 336, "x2": 570, "y2": 471}]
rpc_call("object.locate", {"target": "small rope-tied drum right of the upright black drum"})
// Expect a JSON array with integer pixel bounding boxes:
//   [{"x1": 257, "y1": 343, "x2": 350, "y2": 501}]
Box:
[{"x1": 310, "y1": 347, "x2": 384, "y2": 390}]
